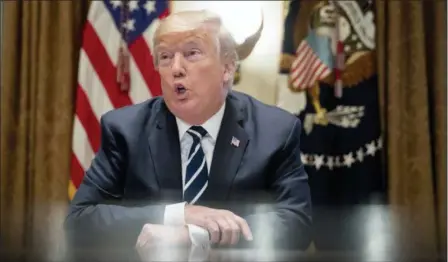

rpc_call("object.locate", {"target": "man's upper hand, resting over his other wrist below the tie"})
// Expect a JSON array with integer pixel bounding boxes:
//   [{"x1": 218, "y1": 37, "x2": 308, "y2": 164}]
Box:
[{"x1": 185, "y1": 205, "x2": 252, "y2": 245}]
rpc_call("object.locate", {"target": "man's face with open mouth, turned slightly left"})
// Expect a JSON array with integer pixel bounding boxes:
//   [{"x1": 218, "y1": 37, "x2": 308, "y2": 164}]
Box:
[{"x1": 155, "y1": 30, "x2": 230, "y2": 124}]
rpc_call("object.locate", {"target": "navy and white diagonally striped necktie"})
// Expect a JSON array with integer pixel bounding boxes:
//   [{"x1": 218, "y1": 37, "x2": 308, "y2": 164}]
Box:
[{"x1": 184, "y1": 126, "x2": 208, "y2": 204}]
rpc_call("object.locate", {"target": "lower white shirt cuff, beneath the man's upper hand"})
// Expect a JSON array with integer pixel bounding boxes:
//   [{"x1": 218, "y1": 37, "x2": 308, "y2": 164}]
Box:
[{"x1": 187, "y1": 225, "x2": 210, "y2": 261}]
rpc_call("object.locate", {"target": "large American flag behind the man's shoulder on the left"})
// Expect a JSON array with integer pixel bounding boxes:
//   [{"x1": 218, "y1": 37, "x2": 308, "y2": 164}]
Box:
[{"x1": 69, "y1": 0, "x2": 170, "y2": 199}]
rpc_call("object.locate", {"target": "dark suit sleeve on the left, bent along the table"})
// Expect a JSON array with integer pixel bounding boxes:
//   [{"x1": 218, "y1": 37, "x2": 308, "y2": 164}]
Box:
[{"x1": 65, "y1": 114, "x2": 165, "y2": 252}]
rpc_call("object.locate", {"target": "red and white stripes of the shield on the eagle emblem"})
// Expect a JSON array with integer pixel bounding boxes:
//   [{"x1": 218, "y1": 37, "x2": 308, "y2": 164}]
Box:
[{"x1": 290, "y1": 40, "x2": 331, "y2": 90}]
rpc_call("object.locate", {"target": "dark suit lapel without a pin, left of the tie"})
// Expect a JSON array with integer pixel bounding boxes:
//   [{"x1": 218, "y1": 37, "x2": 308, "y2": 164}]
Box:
[{"x1": 148, "y1": 101, "x2": 182, "y2": 201}]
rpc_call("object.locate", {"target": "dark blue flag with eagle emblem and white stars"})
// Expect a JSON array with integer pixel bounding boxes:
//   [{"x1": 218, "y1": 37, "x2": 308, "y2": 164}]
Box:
[{"x1": 277, "y1": 0, "x2": 386, "y2": 250}]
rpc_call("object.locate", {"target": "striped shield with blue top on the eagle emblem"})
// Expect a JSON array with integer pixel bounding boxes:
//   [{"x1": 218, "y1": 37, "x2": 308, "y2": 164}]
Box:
[{"x1": 290, "y1": 30, "x2": 333, "y2": 90}]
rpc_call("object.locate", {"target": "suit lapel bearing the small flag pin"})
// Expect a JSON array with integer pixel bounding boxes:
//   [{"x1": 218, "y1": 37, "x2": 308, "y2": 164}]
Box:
[{"x1": 201, "y1": 94, "x2": 249, "y2": 202}]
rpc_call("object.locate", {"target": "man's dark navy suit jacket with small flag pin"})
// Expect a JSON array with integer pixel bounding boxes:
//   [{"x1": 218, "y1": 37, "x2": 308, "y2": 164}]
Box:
[{"x1": 65, "y1": 91, "x2": 312, "y2": 256}]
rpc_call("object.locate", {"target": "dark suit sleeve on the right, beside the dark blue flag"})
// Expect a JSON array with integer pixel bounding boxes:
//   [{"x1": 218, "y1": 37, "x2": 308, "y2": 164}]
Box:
[{"x1": 244, "y1": 119, "x2": 312, "y2": 250}]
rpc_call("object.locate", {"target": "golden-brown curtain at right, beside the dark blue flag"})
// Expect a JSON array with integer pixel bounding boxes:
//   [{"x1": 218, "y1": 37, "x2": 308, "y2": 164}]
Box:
[{"x1": 376, "y1": 0, "x2": 447, "y2": 255}]
